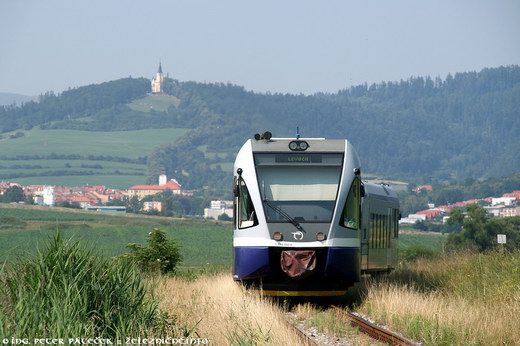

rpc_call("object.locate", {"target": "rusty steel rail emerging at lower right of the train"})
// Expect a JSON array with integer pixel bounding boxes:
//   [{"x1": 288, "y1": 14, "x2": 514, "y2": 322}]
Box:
[{"x1": 332, "y1": 306, "x2": 421, "y2": 346}]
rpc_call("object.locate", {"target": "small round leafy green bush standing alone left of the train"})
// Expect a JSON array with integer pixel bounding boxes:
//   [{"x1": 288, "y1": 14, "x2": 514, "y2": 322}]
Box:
[{"x1": 124, "y1": 228, "x2": 182, "y2": 274}]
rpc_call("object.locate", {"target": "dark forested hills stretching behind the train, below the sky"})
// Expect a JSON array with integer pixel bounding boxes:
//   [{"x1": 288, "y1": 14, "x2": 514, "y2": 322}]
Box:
[{"x1": 0, "y1": 66, "x2": 520, "y2": 188}]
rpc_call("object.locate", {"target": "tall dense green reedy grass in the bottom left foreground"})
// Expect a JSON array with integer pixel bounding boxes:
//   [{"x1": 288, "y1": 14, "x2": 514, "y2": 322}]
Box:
[{"x1": 0, "y1": 233, "x2": 174, "y2": 343}]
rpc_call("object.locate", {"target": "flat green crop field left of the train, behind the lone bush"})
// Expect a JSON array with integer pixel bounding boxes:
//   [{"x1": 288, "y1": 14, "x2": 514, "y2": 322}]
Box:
[{"x1": 0, "y1": 207, "x2": 232, "y2": 268}]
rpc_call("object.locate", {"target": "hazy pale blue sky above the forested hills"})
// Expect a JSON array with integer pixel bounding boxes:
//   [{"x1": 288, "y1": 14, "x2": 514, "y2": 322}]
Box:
[{"x1": 0, "y1": 0, "x2": 520, "y2": 95}]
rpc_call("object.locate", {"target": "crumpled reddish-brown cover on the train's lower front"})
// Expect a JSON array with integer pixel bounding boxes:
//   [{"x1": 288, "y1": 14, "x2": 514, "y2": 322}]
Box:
[{"x1": 280, "y1": 250, "x2": 316, "y2": 279}]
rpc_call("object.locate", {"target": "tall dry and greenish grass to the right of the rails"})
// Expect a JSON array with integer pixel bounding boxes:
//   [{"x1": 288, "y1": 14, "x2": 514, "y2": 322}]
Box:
[{"x1": 360, "y1": 253, "x2": 520, "y2": 345}]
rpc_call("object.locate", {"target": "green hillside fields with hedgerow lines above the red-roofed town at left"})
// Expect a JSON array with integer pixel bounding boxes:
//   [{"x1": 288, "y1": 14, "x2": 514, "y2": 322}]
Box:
[{"x1": 0, "y1": 128, "x2": 187, "y2": 188}]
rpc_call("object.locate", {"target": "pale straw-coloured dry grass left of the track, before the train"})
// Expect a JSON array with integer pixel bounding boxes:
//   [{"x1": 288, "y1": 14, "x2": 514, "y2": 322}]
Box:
[{"x1": 155, "y1": 273, "x2": 310, "y2": 345}]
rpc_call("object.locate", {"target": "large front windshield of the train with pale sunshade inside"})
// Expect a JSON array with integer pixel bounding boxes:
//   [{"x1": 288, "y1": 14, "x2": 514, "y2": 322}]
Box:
[{"x1": 255, "y1": 153, "x2": 343, "y2": 223}]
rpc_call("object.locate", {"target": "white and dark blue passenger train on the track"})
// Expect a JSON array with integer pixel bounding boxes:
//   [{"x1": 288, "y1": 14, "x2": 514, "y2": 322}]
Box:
[{"x1": 233, "y1": 132, "x2": 400, "y2": 297}]
